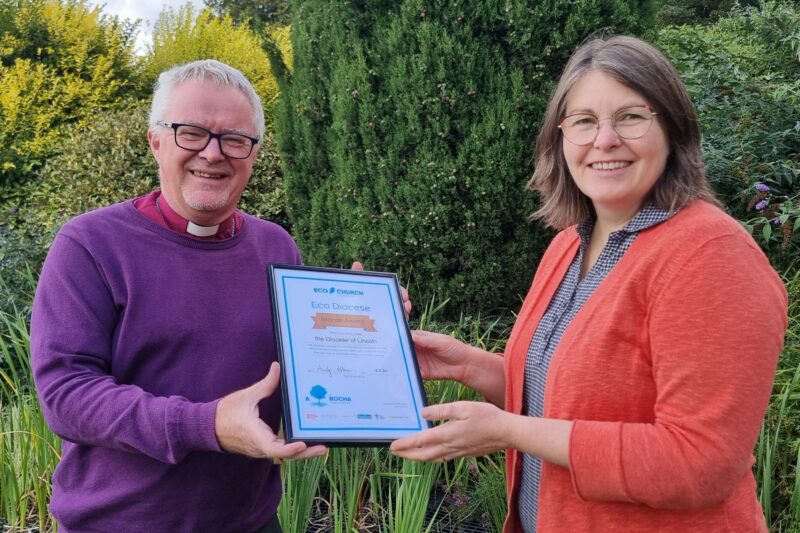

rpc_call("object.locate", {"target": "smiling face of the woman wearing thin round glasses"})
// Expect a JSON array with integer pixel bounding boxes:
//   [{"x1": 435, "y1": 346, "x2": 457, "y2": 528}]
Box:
[{"x1": 562, "y1": 70, "x2": 669, "y2": 227}]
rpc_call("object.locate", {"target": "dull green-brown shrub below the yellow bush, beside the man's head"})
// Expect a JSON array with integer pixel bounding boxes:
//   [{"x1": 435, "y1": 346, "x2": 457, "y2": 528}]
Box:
[{"x1": 0, "y1": 101, "x2": 156, "y2": 306}]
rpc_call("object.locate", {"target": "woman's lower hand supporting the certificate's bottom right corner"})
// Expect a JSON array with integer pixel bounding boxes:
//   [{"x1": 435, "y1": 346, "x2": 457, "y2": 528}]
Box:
[{"x1": 389, "y1": 402, "x2": 514, "y2": 462}]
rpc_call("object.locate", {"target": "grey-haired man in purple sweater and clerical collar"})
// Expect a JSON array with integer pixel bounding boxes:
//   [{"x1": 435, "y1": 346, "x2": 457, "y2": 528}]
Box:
[{"x1": 31, "y1": 60, "x2": 325, "y2": 533}]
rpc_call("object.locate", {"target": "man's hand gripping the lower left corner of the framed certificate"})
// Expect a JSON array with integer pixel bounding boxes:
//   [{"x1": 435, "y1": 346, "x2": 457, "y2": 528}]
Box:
[{"x1": 214, "y1": 363, "x2": 326, "y2": 459}]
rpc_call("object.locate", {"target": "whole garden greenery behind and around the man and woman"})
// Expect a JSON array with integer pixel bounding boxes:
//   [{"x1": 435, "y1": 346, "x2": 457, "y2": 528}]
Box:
[{"x1": 0, "y1": 0, "x2": 800, "y2": 533}]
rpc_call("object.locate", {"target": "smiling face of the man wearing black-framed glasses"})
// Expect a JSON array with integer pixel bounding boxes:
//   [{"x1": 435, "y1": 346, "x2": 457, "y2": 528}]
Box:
[{"x1": 147, "y1": 81, "x2": 258, "y2": 226}]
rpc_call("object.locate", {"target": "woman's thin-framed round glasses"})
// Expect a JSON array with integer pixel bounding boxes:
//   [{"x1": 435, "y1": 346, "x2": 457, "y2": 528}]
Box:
[{"x1": 558, "y1": 106, "x2": 658, "y2": 146}]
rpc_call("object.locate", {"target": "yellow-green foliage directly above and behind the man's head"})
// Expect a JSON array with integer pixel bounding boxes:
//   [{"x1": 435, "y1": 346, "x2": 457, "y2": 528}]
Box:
[{"x1": 144, "y1": 4, "x2": 288, "y2": 113}]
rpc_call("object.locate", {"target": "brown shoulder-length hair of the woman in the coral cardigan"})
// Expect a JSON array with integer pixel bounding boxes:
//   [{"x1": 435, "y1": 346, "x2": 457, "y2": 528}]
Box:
[{"x1": 528, "y1": 36, "x2": 720, "y2": 229}]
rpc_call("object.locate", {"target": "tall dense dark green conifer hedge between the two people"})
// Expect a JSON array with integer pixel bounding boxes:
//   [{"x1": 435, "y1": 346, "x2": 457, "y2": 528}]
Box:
[{"x1": 273, "y1": 0, "x2": 649, "y2": 313}]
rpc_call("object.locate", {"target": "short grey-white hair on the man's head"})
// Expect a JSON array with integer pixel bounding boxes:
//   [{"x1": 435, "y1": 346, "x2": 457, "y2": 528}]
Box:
[{"x1": 148, "y1": 59, "x2": 265, "y2": 139}]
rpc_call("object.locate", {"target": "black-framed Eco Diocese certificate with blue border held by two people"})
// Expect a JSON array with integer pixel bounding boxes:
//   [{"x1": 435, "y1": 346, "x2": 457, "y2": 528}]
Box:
[{"x1": 269, "y1": 264, "x2": 430, "y2": 446}]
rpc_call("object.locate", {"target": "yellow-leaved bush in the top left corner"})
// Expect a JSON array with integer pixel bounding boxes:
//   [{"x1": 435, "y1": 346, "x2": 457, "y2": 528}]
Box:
[{"x1": 0, "y1": 0, "x2": 133, "y2": 183}]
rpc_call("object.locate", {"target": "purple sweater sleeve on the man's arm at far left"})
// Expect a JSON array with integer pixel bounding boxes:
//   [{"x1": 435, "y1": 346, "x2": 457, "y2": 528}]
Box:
[{"x1": 31, "y1": 232, "x2": 219, "y2": 463}]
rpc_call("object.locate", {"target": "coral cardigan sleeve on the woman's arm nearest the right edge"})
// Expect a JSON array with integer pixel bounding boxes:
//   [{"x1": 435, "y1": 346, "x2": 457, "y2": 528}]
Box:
[{"x1": 570, "y1": 235, "x2": 787, "y2": 509}]
